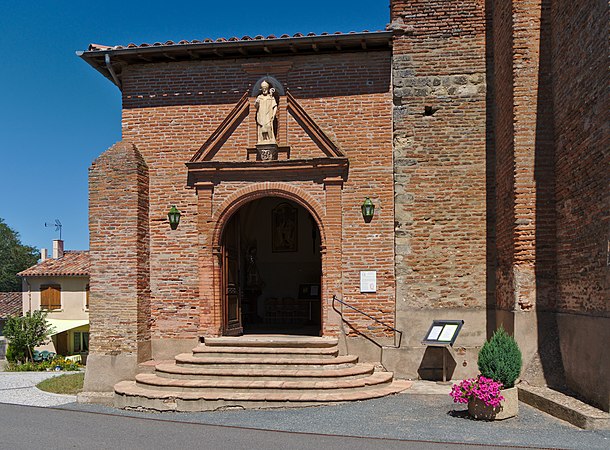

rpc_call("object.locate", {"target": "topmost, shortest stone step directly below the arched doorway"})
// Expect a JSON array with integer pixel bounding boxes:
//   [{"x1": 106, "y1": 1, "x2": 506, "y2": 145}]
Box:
[{"x1": 204, "y1": 334, "x2": 339, "y2": 348}]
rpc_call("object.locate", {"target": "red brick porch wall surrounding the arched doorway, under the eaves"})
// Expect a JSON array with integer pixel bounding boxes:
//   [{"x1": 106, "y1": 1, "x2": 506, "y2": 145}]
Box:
[{"x1": 91, "y1": 50, "x2": 395, "y2": 350}]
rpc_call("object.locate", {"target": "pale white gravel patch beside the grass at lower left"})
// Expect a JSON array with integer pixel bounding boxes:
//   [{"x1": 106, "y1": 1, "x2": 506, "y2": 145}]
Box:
[{"x1": 0, "y1": 372, "x2": 76, "y2": 406}]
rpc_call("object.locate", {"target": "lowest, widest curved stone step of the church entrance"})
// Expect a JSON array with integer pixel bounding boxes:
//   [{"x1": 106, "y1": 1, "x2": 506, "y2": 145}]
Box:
[{"x1": 114, "y1": 380, "x2": 412, "y2": 412}]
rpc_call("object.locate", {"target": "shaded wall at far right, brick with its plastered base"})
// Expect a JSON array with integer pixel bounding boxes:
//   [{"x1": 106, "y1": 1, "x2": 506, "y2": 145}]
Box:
[{"x1": 549, "y1": 0, "x2": 610, "y2": 411}]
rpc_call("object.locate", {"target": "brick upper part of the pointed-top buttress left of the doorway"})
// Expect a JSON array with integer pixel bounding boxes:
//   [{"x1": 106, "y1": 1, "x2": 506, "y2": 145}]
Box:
[{"x1": 89, "y1": 142, "x2": 150, "y2": 359}]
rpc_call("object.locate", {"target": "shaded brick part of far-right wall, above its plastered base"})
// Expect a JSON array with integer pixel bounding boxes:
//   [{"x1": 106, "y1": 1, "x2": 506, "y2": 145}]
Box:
[{"x1": 552, "y1": 1, "x2": 610, "y2": 315}]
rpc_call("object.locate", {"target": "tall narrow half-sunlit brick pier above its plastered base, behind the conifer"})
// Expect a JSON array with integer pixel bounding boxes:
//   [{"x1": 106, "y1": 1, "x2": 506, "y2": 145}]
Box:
[{"x1": 493, "y1": 1, "x2": 556, "y2": 311}]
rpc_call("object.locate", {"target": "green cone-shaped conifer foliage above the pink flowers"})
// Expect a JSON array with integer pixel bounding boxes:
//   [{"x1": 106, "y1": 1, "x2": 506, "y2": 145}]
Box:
[{"x1": 478, "y1": 326, "x2": 521, "y2": 388}]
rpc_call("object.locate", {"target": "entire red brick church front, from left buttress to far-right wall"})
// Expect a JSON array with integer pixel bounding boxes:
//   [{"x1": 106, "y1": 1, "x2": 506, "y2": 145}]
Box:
[{"x1": 84, "y1": 0, "x2": 610, "y2": 410}]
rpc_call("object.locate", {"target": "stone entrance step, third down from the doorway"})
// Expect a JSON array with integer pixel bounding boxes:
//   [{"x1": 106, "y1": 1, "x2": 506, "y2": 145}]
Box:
[{"x1": 176, "y1": 353, "x2": 358, "y2": 369}]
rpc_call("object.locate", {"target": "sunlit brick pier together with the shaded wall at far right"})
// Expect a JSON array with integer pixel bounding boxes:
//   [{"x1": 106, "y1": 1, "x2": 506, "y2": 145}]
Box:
[{"x1": 488, "y1": 0, "x2": 610, "y2": 411}]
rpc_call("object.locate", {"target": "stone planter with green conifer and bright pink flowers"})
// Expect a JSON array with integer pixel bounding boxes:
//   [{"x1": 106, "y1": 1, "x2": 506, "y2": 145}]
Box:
[{"x1": 451, "y1": 327, "x2": 522, "y2": 420}]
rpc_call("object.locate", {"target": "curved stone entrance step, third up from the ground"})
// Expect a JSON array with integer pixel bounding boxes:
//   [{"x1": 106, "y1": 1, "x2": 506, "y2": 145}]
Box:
[{"x1": 154, "y1": 363, "x2": 374, "y2": 381}]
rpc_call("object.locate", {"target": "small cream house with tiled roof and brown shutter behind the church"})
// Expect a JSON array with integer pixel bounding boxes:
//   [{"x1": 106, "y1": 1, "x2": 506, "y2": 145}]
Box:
[{"x1": 18, "y1": 240, "x2": 89, "y2": 362}]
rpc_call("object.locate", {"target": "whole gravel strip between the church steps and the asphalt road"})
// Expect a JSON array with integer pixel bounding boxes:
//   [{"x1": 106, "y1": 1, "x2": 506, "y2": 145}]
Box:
[{"x1": 0, "y1": 372, "x2": 610, "y2": 449}]
